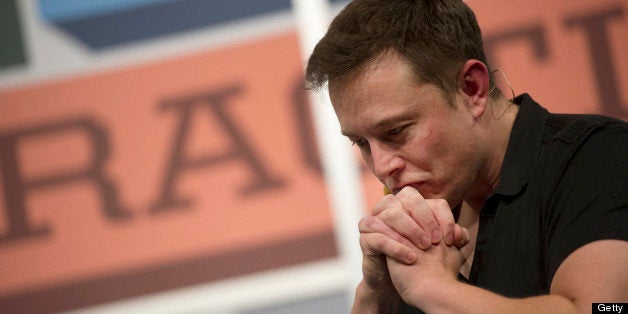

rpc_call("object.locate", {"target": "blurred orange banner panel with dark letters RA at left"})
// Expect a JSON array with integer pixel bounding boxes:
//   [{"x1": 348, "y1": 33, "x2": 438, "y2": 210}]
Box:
[{"x1": 0, "y1": 30, "x2": 335, "y2": 310}]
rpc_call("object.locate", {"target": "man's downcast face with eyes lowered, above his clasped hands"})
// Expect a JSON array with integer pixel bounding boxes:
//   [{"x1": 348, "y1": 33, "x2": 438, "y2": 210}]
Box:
[{"x1": 329, "y1": 55, "x2": 482, "y2": 207}]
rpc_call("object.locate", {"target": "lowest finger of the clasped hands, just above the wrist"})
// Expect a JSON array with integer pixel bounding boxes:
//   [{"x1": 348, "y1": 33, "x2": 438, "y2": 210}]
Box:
[{"x1": 360, "y1": 233, "x2": 417, "y2": 265}]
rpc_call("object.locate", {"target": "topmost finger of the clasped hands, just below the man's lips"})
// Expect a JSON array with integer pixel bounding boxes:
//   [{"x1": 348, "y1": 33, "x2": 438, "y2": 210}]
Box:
[{"x1": 395, "y1": 186, "x2": 443, "y2": 244}]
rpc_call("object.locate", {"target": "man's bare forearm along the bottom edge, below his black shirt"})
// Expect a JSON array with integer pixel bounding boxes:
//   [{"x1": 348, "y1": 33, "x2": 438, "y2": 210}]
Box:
[{"x1": 404, "y1": 281, "x2": 576, "y2": 314}]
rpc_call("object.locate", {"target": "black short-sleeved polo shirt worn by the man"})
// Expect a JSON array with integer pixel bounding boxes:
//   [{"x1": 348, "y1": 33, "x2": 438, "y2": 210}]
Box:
[{"x1": 400, "y1": 94, "x2": 628, "y2": 313}]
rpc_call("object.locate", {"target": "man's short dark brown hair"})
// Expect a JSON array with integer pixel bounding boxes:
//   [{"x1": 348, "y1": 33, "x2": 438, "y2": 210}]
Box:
[{"x1": 305, "y1": 0, "x2": 494, "y2": 99}]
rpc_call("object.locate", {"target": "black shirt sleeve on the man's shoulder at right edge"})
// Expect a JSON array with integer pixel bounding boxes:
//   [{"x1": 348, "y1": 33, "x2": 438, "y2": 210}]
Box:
[{"x1": 546, "y1": 124, "x2": 628, "y2": 282}]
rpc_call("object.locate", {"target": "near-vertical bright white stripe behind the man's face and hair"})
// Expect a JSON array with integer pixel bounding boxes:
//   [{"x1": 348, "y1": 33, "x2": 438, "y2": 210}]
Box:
[{"x1": 292, "y1": 0, "x2": 365, "y2": 302}]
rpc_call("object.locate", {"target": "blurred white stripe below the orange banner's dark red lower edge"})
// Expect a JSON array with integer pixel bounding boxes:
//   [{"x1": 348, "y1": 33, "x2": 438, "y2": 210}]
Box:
[{"x1": 66, "y1": 259, "x2": 347, "y2": 314}]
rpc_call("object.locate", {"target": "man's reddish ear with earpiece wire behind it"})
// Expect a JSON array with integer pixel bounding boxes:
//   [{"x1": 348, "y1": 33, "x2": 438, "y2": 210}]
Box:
[{"x1": 460, "y1": 60, "x2": 490, "y2": 120}]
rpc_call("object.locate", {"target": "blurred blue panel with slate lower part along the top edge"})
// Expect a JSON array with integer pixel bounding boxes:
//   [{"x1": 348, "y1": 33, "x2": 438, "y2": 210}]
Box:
[{"x1": 39, "y1": 0, "x2": 350, "y2": 49}]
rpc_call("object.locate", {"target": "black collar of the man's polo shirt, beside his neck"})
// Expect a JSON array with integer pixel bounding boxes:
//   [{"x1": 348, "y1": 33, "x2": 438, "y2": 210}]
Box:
[{"x1": 494, "y1": 94, "x2": 548, "y2": 196}]
